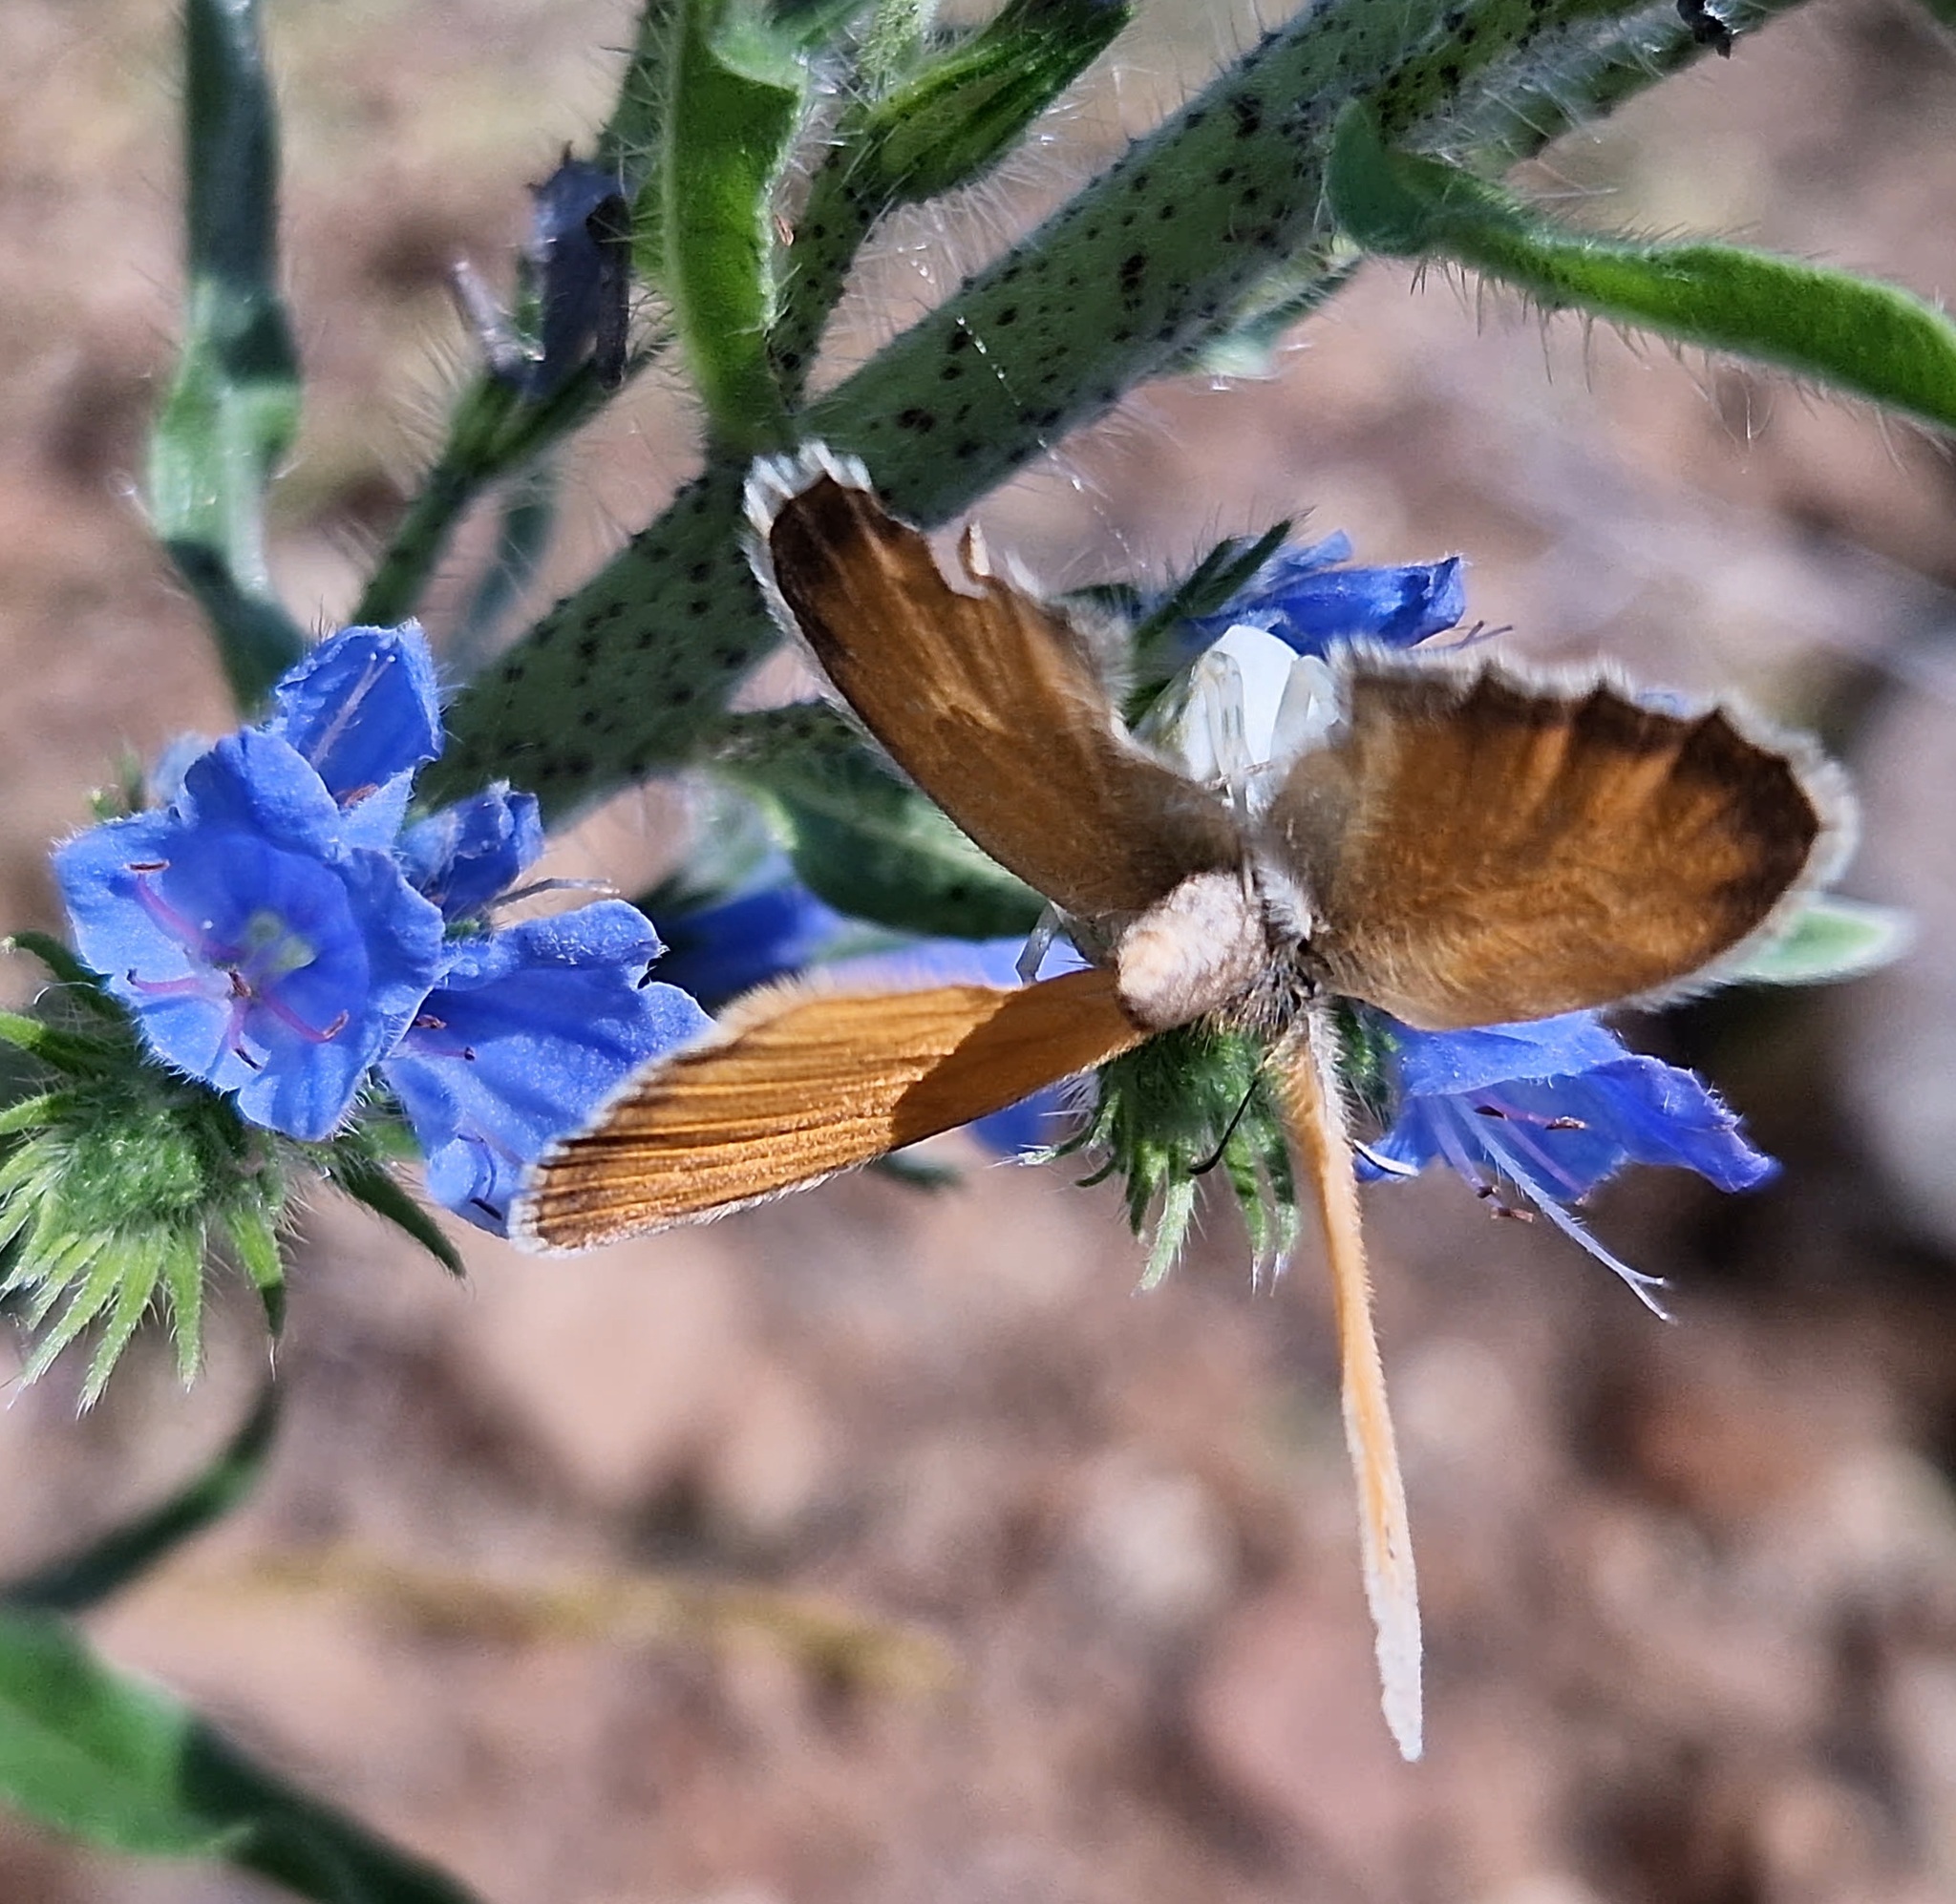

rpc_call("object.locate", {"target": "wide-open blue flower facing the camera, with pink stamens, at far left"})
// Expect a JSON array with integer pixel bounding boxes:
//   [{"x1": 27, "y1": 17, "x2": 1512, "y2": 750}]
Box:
[{"x1": 54, "y1": 730, "x2": 444, "y2": 1142}]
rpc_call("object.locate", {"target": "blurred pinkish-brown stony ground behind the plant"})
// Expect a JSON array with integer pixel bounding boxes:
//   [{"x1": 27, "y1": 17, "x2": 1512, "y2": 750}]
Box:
[{"x1": 0, "y1": 0, "x2": 1956, "y2": 1904}]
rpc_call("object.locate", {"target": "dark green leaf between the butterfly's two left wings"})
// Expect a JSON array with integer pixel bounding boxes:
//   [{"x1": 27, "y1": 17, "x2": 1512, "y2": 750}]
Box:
[{"x1": 714, "y1": 704, "x2": 1047, "y2": 939}]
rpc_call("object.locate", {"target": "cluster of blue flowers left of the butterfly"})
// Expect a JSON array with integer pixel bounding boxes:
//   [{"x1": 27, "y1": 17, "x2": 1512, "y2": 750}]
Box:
[{"x1": 54, "y1": 624, "x2": 708, "y2": 1234}]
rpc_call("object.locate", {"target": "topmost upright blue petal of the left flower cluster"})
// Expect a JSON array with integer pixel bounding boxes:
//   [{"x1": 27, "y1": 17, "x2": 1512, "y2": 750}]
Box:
[{"x1": 266, "y1": 622, "x2": 442, "y2": 805}]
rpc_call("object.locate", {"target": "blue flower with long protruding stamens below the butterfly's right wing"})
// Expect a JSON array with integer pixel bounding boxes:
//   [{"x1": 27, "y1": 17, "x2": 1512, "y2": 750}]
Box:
[{"x1": 1357, "y1": 1012, "x2": 1778, "y2": 1314}]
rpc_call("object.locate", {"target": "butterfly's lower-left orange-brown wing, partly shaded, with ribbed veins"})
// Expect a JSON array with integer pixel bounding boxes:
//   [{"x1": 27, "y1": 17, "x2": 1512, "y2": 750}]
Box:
[{"x1": 508, "y1": 967, "x2": 1144, "y2": 1251}]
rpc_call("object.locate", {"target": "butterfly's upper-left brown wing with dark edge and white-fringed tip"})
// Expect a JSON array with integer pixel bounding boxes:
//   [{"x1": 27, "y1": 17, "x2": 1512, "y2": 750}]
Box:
[{"x1": 747, "y1": 448, "x2": 1242, "y2": 917}]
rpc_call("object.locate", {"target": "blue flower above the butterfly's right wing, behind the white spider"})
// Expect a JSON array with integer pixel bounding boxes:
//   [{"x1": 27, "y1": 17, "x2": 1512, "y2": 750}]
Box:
[{"x1": 1187, "y1": 534, "x2": 1467, "y2": 659}]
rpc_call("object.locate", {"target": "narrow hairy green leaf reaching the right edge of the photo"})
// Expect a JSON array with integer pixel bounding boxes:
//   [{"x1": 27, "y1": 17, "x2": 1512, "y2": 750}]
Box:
[{"x1": 1327, "y1": 101, "x2": 1956, "y2": 428}]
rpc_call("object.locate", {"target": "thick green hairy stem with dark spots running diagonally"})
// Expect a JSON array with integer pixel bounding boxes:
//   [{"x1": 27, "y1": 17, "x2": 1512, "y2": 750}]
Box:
[{"x1": 426, "y1": 0, "x2": 1792, "y2": 815}]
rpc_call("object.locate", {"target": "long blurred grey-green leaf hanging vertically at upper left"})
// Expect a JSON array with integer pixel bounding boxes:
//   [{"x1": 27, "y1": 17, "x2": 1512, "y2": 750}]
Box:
[{"x1": 149, "y1": 0, "x2": 308, "y2": 709}]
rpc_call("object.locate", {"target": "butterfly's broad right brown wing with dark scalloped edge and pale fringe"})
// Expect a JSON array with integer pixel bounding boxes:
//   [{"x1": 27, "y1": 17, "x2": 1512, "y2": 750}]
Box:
[{"x1": 1260, "y1": 653, "x2": 1844, "y2": 1030}]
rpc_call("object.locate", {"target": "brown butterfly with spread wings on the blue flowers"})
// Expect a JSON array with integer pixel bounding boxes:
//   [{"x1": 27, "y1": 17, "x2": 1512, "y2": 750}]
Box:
[{"x1": 511, "y1": 448, "x2": 1846, "y2": 1757}]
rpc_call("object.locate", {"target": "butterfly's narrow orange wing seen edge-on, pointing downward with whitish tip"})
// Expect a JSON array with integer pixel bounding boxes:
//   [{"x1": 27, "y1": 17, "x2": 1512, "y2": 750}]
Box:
[{"x1": 1273, "y1": 1005, "x2": 1420, "y2": 1760}]
